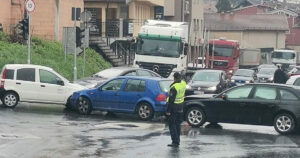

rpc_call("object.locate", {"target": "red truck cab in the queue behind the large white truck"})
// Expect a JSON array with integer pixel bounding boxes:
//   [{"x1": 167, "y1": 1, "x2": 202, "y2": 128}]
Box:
[{"x1": 205, "y1": 39, "x2": 240, "y2": 76}]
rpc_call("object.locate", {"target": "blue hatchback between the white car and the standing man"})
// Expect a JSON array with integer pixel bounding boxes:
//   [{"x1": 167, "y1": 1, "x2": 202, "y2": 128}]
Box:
[{"x1": 70, "y1": 76, "x2": 172, "y2": 120}]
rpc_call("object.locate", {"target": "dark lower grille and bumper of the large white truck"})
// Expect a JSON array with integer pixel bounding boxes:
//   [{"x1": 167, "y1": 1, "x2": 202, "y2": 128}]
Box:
[{"x1": 136, "y1": 62, "x2": 177, "y2": 78}]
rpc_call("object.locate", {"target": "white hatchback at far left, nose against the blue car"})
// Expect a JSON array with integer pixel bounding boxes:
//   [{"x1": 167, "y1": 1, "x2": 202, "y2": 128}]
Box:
[{"x1": 0, "y1": 64, "x2": 85, "y2": 108}]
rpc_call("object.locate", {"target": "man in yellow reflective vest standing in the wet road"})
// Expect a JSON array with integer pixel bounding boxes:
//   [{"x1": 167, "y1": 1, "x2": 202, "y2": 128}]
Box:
[{"x1": 166, "y1": 72, "x2": 186, "y2": 147}]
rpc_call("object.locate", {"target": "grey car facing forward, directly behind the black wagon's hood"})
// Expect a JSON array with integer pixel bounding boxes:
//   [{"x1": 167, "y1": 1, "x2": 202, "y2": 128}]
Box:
[{"x1": 186, "y1": 70, "x2": 228, "y2": 95}]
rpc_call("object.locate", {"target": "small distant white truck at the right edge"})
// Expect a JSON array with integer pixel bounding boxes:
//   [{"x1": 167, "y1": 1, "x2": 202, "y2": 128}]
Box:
[{"x1": 271, "y1": 49, "x2": 300, "y2": 68}]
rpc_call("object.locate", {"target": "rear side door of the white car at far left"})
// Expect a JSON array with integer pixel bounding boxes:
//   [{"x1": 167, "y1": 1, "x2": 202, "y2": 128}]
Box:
[{"x1": 15, "y1": 68, "x2": 39, "y2": 101}]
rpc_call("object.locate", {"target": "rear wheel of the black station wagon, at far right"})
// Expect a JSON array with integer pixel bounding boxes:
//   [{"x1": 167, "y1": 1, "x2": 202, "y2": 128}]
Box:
[{"x1": 273, "y1": 113, "x2": 296, "y2": 134}]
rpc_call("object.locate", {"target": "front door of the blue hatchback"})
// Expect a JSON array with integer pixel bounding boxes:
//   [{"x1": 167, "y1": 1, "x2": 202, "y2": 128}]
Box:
[{"x1": 93, "y1": 78, "x2": 125, "y2": 110}]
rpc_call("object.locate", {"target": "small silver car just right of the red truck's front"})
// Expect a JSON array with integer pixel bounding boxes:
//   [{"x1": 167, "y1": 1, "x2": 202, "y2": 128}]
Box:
[{"x1": 231, "y1": 69, "x2": 257, "y2": 85}]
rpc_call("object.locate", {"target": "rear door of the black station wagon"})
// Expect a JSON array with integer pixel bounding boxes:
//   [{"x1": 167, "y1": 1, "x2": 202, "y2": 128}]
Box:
[{"x1": 240, "y1": 85, "x2": 279, "y2": 125}]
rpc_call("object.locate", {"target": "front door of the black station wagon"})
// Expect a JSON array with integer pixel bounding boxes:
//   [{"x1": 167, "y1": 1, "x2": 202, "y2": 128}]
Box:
[{"x1": 207, "y1": 85, "x2": 253, "y2": 123}]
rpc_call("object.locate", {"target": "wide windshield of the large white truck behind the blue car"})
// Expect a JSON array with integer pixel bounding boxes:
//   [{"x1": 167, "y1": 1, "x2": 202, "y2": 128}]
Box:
[{"x1": 137, "y1": 39, "x2": 182, "y2": 58}]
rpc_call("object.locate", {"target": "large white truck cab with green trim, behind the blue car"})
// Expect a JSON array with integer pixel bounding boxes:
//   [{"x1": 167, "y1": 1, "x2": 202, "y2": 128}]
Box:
[{"x1": 134, "y1": 20, "x2": 189, "y2": 78}]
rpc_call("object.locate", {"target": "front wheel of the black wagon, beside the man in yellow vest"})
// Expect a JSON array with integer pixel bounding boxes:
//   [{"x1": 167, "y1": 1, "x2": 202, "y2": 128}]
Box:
[{"x1": 185, "y1": 107, "x2": 206, "y2": 127}]
